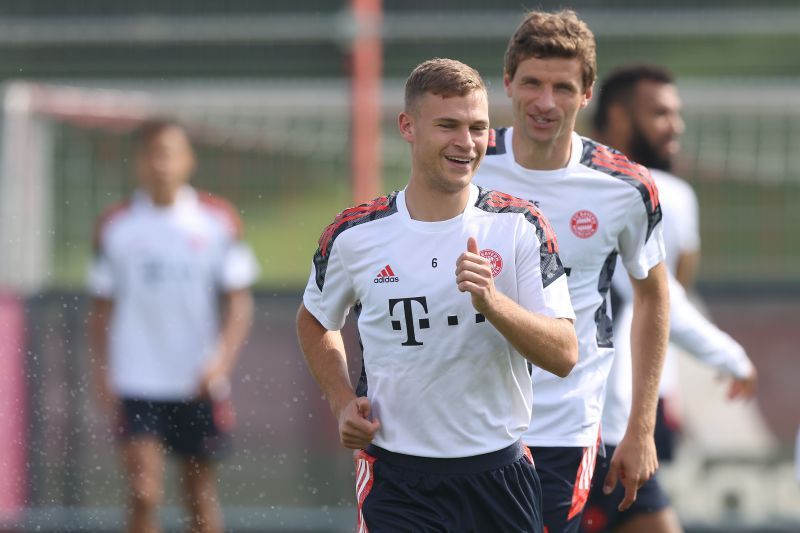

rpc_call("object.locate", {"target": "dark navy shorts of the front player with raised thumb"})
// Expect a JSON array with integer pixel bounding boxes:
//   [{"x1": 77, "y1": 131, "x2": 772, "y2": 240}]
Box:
[{"x1": 355, "y1": 444, "x2": 542, "y2": 533}]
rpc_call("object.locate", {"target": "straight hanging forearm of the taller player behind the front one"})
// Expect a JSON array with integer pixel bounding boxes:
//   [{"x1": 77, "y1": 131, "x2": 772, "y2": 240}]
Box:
[{"x1": 628, "y1": 263, "x2": 669, "y2": 435}]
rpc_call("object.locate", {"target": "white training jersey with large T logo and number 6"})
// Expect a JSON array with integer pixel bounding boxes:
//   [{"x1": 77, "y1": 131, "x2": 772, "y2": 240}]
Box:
[{"x1": 303, "y1": 185, "x2": 574, "y2": 457}]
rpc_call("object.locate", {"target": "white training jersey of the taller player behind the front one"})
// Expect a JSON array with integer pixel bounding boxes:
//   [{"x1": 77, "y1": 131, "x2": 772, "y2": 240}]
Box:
[{"x1": 475, "y1": 128, "x2": 664, "y2": 447}]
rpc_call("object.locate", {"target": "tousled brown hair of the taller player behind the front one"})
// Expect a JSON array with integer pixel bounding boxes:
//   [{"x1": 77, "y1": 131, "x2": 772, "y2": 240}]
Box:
[{"x1": 503, "y1": 9, "x2": 597, "y2": 90}]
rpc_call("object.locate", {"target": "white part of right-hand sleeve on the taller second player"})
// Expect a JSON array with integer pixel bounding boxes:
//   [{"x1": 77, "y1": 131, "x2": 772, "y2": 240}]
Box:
[{"x1": 617, "y1": 194, "x2": 666, "y2": 279}]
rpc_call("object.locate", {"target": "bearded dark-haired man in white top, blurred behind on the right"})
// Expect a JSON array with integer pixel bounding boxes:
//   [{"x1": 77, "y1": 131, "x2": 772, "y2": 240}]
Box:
[{"x1": 584, "y1": 65, "x2": 757, "y2": 533}]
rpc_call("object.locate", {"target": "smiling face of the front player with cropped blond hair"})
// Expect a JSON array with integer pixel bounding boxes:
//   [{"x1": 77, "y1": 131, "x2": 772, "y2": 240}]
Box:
[{"x1": 398, "y1": 90, "x2": 489, "y2": 193}]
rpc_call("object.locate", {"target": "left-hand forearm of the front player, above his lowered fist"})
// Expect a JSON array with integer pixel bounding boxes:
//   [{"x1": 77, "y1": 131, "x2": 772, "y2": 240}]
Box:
[{"x1": 297, "y1": 305, "x2": 356, "y2": 418}]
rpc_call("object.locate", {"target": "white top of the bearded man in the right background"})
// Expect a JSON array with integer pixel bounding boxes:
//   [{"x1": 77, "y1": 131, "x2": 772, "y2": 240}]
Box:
[{"x1": 603, "y1": 170, "x2": 752, "y2": 445}]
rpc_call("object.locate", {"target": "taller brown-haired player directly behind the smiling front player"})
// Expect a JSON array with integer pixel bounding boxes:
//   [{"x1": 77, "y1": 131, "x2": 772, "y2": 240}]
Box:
[{"x1": 475, "y1": 11, "x2": 668, "y2": 533}]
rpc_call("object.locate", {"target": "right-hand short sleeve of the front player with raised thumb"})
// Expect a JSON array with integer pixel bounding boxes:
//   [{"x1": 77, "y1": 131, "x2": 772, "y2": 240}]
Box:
[{"x1": 516, "y1": 213, "x2": 575, "y2": 319}]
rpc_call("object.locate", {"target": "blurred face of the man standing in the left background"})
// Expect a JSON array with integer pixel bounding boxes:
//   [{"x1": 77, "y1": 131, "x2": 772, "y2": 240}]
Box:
[{"x1": 136, "y1": 127, "x2": 194, "y2": 197}]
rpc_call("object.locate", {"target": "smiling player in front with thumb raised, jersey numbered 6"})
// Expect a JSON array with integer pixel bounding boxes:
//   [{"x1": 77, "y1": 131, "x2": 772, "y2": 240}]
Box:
[{"x1": 297, "y1": 59, "x2": 578, "y2": 532}]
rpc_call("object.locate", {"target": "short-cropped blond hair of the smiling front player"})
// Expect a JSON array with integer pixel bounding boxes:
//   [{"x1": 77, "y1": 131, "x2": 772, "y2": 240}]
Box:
[{"x1": 405, "y1": 57, "x2": 486, "y2": 112}]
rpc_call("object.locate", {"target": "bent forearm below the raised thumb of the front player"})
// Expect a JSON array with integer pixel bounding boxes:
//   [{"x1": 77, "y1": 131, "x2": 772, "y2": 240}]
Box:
[{"x1": 485, "y1": 292, "x2": 578, "y2": 377}]
